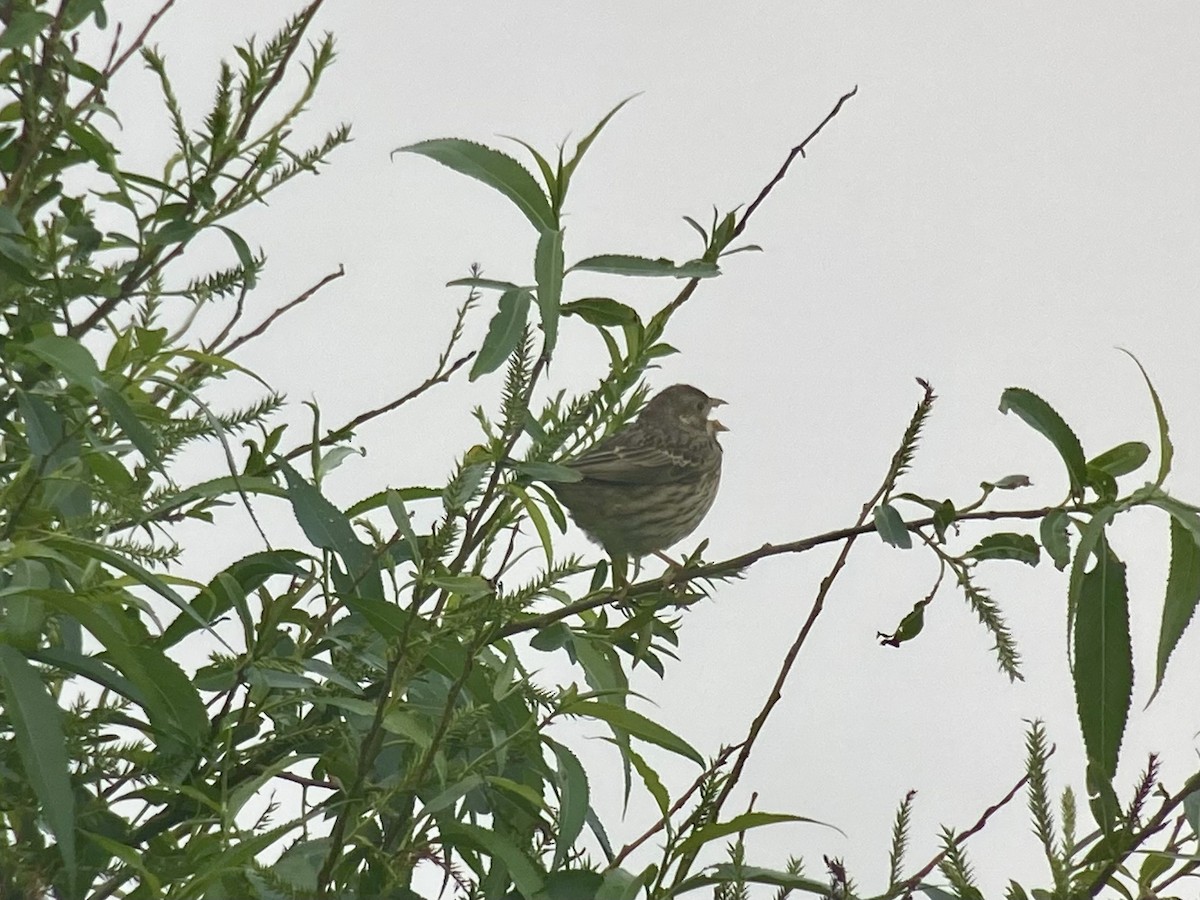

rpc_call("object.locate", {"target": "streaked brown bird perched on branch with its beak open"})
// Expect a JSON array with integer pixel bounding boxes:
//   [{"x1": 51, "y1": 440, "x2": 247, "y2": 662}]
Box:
[{"x1": 550, "y1": 384, "x2": 728, "y2": 557}]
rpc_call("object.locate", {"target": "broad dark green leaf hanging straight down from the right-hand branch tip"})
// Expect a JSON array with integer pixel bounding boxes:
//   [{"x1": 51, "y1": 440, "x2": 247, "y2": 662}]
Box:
[{"x1": 1074, "y1": 541, "x2": 1133, "y2": 782}]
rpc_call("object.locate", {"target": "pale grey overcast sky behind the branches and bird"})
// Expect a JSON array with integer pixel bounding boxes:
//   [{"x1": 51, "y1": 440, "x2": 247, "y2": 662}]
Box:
[{"x1": 110, "y1": 0, "x2": 1200, "y2": 893}]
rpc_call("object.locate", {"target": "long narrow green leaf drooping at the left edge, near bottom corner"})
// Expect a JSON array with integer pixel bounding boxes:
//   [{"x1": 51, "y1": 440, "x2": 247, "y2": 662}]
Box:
[{"x1": 0, "y1": 644, "x2": 76, "y2": 883}]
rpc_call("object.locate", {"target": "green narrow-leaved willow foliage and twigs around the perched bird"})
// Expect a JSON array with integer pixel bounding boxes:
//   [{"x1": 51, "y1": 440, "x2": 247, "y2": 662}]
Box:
[{"x1": 0, "y1": 0, "x2": 1200, "y2": 900}]
